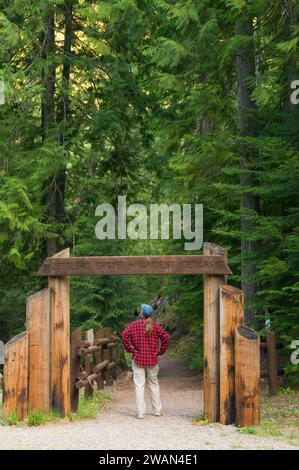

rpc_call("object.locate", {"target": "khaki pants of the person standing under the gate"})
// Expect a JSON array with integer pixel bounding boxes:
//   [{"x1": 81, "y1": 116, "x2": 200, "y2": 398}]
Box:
[{"x1": 132, "y1": 361, "x2": 162, "y2": 416}]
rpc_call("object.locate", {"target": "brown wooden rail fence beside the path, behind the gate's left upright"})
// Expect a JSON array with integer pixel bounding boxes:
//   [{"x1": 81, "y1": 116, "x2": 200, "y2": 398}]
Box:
[{"x1": 71, "y1": 328, "x2": 116, "y2": 411}]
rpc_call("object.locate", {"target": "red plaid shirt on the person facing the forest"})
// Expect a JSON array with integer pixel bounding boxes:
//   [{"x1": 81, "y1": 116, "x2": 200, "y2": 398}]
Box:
[{"x1": 121, "y1": 319, "x2": 169, "y2": 367}]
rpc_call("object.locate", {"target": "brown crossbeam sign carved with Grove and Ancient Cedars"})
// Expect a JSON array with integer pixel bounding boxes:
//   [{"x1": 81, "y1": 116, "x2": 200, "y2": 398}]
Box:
[{"x1": 38, "y1": 255, "x2": 232, "y2": 276}]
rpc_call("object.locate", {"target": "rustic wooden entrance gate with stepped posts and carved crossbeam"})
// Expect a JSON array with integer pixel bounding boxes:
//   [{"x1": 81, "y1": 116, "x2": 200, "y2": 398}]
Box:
[{"x1": 3, "y1": 243, "x2": 259, "y2": 425}]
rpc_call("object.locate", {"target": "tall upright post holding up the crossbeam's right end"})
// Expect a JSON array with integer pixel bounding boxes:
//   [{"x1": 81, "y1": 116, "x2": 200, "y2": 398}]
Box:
[{"x1": 203, "y1": 243, "x2": 226, "y2": 423}]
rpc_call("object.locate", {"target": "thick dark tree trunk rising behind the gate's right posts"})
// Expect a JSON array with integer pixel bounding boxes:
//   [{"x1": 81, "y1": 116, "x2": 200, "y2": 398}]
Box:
[{"x1": 236, "y1": 14, "x2": 259, "y2": 322}]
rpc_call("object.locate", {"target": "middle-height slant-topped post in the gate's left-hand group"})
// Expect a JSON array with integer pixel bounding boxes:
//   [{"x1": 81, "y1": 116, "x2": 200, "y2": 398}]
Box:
[{"x1": 26, "y1": 289, "x2": 50, "y2": 414}]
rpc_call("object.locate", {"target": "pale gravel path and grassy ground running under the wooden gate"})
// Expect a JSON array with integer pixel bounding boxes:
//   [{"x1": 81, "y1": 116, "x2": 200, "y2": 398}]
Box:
[{"x1": 0, "y1": 356, "x2": 299, "y2": 450}]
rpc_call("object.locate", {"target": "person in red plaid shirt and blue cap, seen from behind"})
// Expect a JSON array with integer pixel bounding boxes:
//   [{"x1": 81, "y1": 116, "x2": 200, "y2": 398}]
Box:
[{"x1": 121, "y1": 304, "x2": 169, "y2": 419}]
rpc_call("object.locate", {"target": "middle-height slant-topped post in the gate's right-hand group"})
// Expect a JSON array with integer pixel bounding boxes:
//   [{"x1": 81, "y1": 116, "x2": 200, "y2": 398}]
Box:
[{"x1": 220, "y1": 285, "x2": 244, "y2": 424}]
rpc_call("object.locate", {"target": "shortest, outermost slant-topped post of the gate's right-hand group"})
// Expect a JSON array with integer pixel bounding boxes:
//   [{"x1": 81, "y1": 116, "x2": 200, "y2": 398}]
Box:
[{"x1": 235, "y1": 326, "x2": 260, "y2": 427}]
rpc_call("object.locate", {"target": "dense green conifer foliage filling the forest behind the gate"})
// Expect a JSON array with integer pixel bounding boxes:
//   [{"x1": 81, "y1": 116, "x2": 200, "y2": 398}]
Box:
[{"x1": 0, "y1": 0, "x2": 299, "y2": 383}]
